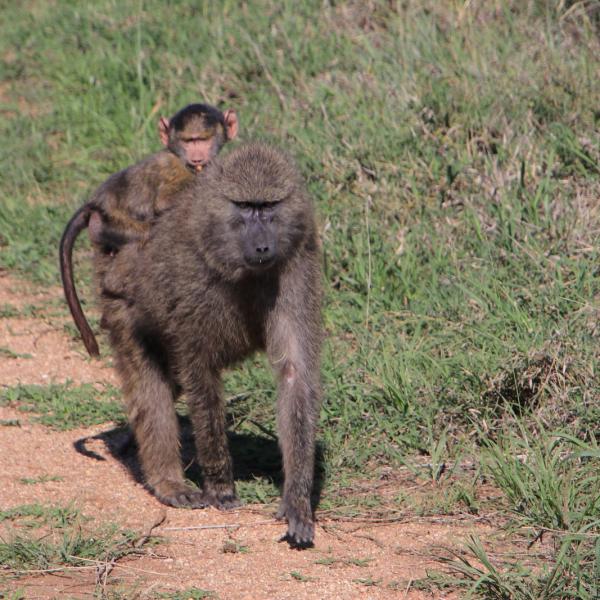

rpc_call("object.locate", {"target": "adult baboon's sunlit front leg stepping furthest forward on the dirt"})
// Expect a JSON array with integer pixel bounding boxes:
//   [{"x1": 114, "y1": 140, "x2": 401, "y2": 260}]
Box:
[{"x1": 268, "y1": 323, "x2": 320, "y2": 546}]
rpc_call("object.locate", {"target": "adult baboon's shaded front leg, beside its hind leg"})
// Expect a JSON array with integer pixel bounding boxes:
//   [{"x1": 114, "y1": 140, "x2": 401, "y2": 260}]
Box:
[{"x1": 187, "y1": 371, "x2": 240, "y2": 509}]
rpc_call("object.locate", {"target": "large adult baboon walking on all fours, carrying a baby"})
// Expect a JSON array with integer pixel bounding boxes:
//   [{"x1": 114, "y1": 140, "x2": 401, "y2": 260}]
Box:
[{"x1": 101, "y1": 144, "x2": 321, "y2": 546}]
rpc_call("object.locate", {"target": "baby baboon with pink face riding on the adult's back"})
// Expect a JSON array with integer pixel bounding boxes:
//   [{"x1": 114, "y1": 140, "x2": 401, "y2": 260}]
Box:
[{"x1": 60, "y1": 104, "x2": 238, "y2": 356}]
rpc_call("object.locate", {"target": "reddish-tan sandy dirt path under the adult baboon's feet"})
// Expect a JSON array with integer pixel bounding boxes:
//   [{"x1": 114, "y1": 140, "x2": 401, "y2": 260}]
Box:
[{"x1": 0, "y1": 275, "x2": 486, "y2": 600}]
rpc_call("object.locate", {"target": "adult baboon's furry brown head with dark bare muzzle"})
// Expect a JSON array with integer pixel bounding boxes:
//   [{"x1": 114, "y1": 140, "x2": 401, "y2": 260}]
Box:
[{"x1": 193, "y1": 143, "x2": 314, "y2": 280}]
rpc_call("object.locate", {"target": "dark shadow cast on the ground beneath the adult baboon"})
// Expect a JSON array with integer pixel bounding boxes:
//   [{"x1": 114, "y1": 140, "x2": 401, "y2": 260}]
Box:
[{"x1": 73, "y1": 416, "x2": 325, "y2": 509}]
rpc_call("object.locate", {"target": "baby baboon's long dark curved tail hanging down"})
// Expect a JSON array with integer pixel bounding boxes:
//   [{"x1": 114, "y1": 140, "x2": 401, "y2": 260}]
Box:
[{"x1": 60, "y1": 204, "x2": 100, "y2": 356}]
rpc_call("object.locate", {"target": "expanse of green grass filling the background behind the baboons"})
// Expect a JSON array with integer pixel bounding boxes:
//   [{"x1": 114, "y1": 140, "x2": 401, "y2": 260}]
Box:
[{"x1": 0, "y1": 0, "x2": 600, "y2": 598}]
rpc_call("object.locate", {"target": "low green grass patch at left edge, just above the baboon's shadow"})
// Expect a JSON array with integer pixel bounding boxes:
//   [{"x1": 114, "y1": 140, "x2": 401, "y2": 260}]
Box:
[{"x1": 0, "y1": 383, "x2": 124, "y2": 431}]
